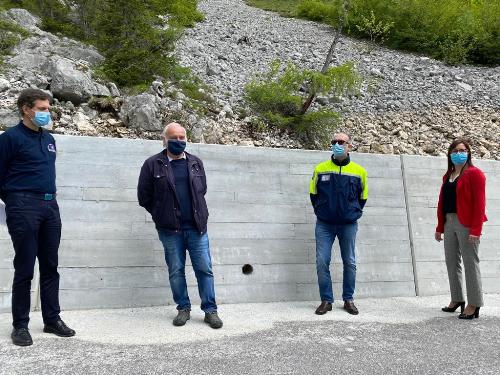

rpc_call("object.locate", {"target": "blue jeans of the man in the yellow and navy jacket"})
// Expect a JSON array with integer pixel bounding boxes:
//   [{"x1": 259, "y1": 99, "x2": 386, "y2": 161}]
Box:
[{"x1": 316, "y1": 220, "x2": 358, "y2": 303}]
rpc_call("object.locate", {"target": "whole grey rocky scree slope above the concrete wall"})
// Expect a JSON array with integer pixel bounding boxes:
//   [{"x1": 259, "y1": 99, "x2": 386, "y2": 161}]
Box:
[{"x1": 0, "y1": 0, "x2": 500, "y2": 160}]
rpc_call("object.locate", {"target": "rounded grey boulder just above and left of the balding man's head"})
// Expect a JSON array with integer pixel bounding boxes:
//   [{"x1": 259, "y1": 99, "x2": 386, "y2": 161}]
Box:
[{"x1": 120, "y1": 93, "x2": 163, "y2": 131}]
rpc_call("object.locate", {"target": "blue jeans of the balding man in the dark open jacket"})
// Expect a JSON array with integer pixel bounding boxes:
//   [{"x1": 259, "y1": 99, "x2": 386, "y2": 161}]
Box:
[{"x1": 158, "y1": 229, "x2": 217, "y2": 313}]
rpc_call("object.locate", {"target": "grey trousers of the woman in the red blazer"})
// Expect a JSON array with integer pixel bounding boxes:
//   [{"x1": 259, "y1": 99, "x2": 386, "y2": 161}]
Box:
[{"x1": 444, "y1": 214, "x2": 483, "y2": 307}]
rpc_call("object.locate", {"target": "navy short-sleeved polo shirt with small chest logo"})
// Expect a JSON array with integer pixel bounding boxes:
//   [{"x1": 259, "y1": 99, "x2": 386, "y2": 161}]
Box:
[{"x1": 0, "y1": 121, "x2": 56, "y2": 200}]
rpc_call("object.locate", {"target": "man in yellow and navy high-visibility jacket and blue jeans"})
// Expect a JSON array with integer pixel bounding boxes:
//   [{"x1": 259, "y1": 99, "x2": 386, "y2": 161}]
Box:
[{"x1": 310, "y1": 133, "x2": 368, "y2": 315}]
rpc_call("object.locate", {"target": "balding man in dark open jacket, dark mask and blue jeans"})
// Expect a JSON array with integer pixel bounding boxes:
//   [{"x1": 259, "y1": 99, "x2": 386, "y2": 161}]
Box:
[{"x1": 137, "y1": 123, "x2": 222, "y2": 328}]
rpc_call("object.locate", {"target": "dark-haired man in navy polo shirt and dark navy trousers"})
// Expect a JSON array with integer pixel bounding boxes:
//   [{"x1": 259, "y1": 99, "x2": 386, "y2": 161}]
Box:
[{"x1": 0, "y1": 89, "x2": 75, "y2": 346}]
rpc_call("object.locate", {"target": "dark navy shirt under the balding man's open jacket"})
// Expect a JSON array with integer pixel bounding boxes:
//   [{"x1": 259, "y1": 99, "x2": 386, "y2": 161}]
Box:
[{"x1": 170, "y1": 159, "x2": 196, "y2": 229}]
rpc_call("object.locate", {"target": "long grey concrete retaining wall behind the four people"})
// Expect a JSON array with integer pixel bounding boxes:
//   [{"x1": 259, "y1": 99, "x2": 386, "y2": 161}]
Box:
[{"x1": 0, "y1": 136, "x2": 500, "y2": 311}]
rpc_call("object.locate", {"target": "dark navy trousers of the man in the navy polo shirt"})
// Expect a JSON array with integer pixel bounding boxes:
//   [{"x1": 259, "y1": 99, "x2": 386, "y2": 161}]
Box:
[{"x1": 5, "y1": 193, "x2": 61, "y2": 328}]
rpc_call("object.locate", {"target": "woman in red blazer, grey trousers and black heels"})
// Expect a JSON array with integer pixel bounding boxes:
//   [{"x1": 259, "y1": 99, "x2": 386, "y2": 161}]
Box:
[{"x1": 435, "y1": 139, "x2": 487, "y2": 319}]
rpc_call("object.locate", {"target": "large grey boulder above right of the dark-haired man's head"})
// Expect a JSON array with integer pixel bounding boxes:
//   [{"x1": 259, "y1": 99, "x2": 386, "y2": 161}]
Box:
[{"x1": 47, "y1": 57, "x2": 111, "y2": 105}]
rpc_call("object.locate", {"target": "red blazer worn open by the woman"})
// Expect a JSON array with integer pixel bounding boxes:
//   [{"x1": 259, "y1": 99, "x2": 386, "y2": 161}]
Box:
[{"x1": 436, "y1": 166, "x2": 488, "y2": 236}]
